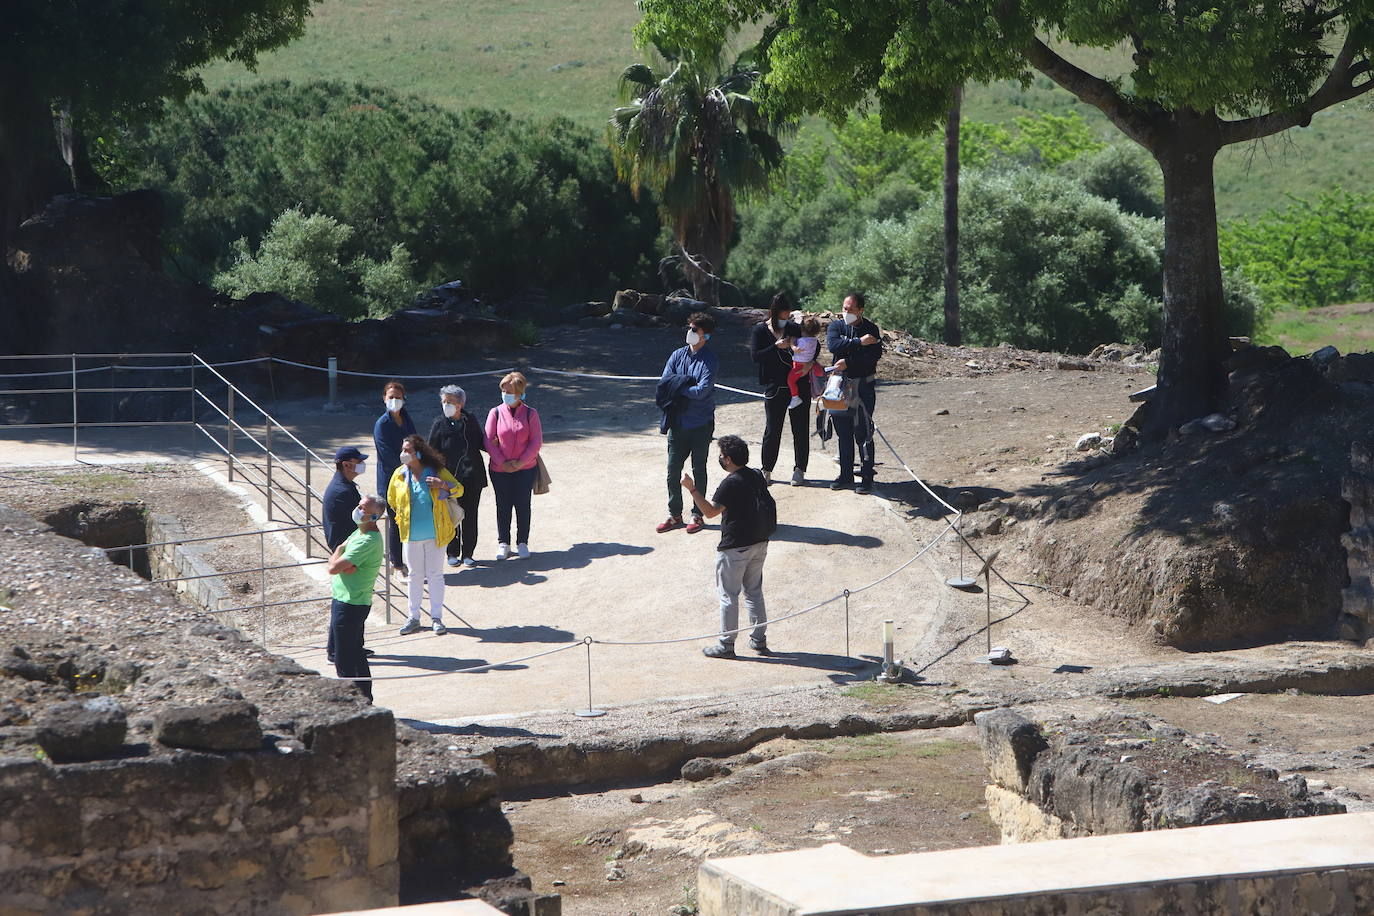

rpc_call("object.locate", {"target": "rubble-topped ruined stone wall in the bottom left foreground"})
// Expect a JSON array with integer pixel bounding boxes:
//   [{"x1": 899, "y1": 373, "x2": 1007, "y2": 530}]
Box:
[{"x1": 0, "y1": 505, "x2": 400, "y2": 915}]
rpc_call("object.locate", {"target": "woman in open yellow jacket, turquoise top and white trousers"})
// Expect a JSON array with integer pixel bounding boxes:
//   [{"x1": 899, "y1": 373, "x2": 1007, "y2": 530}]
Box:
[{"x1": 386, "y1": 435, "x2": 463, "y2": 636}]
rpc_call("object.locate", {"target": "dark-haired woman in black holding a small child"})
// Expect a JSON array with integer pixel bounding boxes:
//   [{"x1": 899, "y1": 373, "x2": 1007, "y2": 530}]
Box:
[{"x1": 749, "y1": 293, "x2": 811, "y2": 486}]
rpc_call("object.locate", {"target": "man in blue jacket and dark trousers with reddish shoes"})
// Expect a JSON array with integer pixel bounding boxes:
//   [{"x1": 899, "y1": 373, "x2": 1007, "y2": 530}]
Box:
[{"x1": 657, "y1": 312, "x2": 720, "y2": 534}]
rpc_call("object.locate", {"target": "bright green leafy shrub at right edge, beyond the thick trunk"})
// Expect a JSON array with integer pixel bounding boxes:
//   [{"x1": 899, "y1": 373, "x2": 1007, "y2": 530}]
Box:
[{"x1": 1220, "y1": 190, "x2": 1374, "y2": 309}]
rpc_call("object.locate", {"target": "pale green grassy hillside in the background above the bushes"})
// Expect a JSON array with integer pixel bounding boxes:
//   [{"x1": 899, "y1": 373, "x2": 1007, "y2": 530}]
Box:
[{"x1": 206, "y1": 0, "x2": 1374, "y2": 217}]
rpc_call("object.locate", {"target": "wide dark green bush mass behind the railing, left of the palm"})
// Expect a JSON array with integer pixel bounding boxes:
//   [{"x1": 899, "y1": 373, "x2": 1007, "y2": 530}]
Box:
[{"x1": 101, "y1": 81, "x2": 658, "y2": 304}]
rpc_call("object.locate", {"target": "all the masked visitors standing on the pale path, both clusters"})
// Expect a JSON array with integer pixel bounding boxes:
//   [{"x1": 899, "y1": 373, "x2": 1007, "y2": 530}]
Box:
[{"x1": 323, "y1": 293, "x2": 882, "y2": 698}]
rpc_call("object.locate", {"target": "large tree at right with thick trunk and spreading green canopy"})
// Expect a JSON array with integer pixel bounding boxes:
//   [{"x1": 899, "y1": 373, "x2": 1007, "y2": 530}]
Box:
[{"x1": 639, "y1": 0, "x2": 1374, "y2": 433}]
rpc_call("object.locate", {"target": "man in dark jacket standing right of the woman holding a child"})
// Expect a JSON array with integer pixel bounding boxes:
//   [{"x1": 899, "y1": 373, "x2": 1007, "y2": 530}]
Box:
[{"x1": 826, "y1": 293, "x2": 882, "y2": 493}]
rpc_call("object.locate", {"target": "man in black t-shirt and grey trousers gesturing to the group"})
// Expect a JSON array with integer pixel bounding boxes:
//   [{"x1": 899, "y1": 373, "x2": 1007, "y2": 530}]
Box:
[{"x1": 682, "y1": 435, "x2": 771, "y2": 658}]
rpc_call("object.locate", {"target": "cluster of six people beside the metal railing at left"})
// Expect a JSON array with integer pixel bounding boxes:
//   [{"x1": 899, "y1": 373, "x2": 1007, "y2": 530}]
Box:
[{"x1": 322, "y1": 372, "x2": 544, "y2": 698}]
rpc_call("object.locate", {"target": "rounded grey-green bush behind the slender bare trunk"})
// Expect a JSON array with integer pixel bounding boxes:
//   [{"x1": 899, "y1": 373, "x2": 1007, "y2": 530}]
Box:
[{"x1": 822, "y1": 170, "x2": 1254, "y2": 353}]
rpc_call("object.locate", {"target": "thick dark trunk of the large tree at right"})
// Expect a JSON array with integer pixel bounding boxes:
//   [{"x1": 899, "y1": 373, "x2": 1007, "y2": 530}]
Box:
[{"x1": 1143, "y1": 130, "x2": 1230, "y2": 435}]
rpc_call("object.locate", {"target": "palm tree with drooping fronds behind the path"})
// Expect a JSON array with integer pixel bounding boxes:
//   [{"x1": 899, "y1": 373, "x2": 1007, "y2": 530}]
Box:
[{"x1": 610, "y1": 47, "x2": 785, "y2": 305}]
